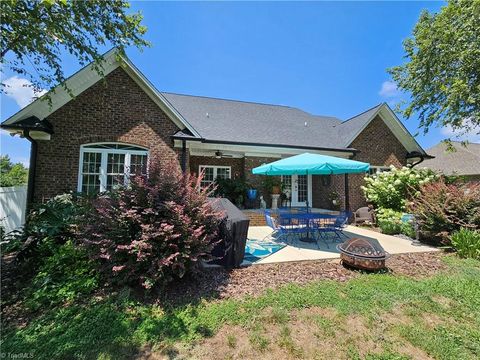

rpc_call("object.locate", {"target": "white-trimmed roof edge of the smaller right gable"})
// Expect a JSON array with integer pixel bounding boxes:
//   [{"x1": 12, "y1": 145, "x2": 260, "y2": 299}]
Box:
[{"x1": 344, "y1": 103, "x2": 425, "y2": 154}]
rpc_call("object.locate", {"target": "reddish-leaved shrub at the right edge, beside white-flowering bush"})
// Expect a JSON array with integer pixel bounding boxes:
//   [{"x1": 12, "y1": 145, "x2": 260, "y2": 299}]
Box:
[{"x1": 409, "y1": 180, "x2": 480, "y2": 244}]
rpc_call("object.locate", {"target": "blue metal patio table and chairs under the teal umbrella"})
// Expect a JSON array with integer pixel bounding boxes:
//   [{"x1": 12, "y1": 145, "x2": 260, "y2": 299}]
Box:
[{"x1": 265, "y1": 208, "x2": 351, "y2": 248}]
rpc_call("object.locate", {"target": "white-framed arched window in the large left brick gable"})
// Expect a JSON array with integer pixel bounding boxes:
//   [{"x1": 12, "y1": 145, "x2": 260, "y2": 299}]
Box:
[{"x1": 77, "y1": 143, "x2": 148, "y2": 194}]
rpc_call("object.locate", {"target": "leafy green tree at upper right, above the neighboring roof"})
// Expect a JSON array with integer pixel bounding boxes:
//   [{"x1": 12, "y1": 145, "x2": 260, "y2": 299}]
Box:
[{"x1": 388, "y1": 0, "x2": 480, "y2": 139}]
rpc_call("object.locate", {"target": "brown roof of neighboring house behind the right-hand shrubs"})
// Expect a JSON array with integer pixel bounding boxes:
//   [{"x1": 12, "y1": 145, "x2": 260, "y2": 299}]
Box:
[{"x1": 421, "y1": 141, "x2": 480, "y2": 182}]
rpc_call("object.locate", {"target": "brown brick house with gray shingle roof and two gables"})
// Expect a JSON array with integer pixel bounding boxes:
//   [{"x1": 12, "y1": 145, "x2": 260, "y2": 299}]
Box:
[{"x1": 2, "y1": 50, "x2": 428, "y2": 209}]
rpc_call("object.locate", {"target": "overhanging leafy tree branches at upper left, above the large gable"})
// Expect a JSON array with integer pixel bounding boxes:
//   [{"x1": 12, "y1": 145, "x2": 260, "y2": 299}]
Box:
[{"x1": 0, "y1": 0, "x2": 148, "y2": 96}]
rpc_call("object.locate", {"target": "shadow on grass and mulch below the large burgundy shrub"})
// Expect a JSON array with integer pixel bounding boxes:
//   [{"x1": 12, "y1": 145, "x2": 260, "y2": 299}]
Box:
[{"x1": 2, "y1": 269, "x2": 229, "y2": 359}]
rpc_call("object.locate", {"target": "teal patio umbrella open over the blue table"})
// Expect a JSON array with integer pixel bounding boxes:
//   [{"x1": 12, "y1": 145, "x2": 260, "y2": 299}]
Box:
[{"x1": 252, "y1": 153, "x2": 370, "y2": 210}]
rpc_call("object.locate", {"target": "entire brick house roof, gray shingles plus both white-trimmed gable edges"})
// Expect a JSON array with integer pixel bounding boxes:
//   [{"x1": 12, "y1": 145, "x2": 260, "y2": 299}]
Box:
[{"x1": 2, "y1": 49, "x2": 425, "y2": 154}]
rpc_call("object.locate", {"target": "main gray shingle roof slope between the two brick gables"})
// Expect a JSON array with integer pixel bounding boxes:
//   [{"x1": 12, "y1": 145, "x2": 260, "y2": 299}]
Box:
[{"x1": 162, "y1": 93, "x2": 378, "y2": 149}]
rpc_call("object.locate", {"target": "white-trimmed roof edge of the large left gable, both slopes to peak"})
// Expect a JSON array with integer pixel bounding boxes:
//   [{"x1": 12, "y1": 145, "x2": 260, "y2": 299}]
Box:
[{"x1": 3, "y1": 49, "x2": 200, "y2": 137}]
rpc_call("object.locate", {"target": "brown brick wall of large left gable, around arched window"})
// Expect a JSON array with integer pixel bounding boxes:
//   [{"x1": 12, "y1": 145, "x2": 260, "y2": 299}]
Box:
[{"x1": 35, "y1": 68, "x2": 181, "y2": 201}]
